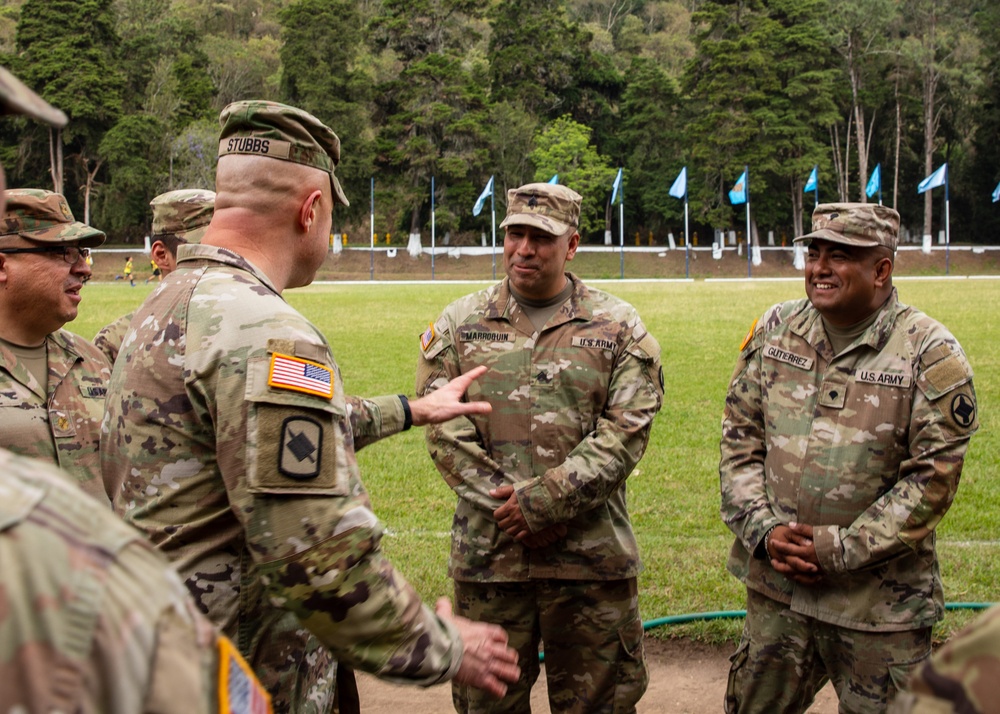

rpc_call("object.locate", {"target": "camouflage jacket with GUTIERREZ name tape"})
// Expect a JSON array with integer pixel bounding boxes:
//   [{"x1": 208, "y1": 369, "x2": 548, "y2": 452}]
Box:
[{"x1": 719, "y1": 290, "x2": 978, "y2": 632}]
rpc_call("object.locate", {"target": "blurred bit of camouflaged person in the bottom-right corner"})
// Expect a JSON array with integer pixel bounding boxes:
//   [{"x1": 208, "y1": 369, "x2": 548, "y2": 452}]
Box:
[{"x1": 889, "y1": 606, "x2": 1000, "y2": 714}]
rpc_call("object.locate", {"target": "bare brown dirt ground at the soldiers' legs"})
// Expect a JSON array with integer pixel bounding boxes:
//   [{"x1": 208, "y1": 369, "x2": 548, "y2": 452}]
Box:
[{"x1": 358, "y1": 637, "x2": 837, "y2": 714}]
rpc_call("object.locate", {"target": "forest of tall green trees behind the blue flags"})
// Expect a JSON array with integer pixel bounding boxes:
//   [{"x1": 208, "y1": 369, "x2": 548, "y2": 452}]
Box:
[{"x1": 0, "y1": 0, "x2": 1000, "y2": 250}]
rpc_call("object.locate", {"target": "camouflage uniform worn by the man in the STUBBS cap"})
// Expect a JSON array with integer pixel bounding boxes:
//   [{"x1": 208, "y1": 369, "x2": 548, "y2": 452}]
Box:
[{"x1": 102, "y1": 245, "x2": 462, "y2": 712}]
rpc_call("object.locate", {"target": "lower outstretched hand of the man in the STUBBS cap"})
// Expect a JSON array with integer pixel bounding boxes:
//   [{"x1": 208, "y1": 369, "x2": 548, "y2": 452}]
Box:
[{"x1": 434, "y1": 597, "x2": 521, "y2": 699}]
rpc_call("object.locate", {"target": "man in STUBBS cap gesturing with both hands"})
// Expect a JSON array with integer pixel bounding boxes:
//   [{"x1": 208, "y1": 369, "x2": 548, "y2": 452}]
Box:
[{"x1": 102, "y1": 101, "x2": 518, "y2": 714}]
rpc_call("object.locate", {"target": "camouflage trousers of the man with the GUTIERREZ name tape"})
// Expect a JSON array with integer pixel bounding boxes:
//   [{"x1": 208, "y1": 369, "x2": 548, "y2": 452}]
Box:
[{"x1": 726, "y1": 590, "x2": 931, "y2": 714}]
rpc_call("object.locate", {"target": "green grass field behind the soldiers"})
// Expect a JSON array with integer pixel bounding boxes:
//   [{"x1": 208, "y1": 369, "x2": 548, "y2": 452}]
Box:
[{"x1": 80, "y1": 279, "x2": 1000, "y2": 641}]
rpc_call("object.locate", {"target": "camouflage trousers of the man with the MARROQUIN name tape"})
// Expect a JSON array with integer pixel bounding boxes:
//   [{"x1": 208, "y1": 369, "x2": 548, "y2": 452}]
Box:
[{"x1": 452, "y1": 578, "x2": 649, "y2": 714}]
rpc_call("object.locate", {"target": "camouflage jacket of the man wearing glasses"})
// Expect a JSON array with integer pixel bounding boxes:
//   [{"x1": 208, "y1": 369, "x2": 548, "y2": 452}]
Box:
[{"x1": 0, "y1": 330, "x2": 111, "y2": 503}]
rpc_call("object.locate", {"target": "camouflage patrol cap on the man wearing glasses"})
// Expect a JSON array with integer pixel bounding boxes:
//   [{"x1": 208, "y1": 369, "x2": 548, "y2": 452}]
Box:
[{"x1": 0, "y1": 188, "x2": 105, "y2": 248}]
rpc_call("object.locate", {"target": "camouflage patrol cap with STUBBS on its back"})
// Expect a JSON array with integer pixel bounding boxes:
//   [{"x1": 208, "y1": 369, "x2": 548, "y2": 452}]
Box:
[{"x1": 219, "y1": 100, "x2": 350, "y2": 206}]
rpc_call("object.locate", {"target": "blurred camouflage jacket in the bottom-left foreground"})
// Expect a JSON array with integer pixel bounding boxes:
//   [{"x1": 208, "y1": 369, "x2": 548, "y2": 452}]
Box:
[{"x1": 0, "y1": 449, "x2": 266, "y2": 714}]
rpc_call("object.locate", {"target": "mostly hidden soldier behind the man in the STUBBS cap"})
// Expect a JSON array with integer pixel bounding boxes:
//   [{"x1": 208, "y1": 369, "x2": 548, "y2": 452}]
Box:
[{"x1": 94, "y1": 188, "x2": 215, "y2": 363}]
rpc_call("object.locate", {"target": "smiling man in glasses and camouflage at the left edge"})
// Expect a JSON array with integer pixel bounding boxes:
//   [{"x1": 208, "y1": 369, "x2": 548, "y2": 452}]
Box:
[{"x1": 0, "y1": 188, "x2": 111, "y2": 503}]
